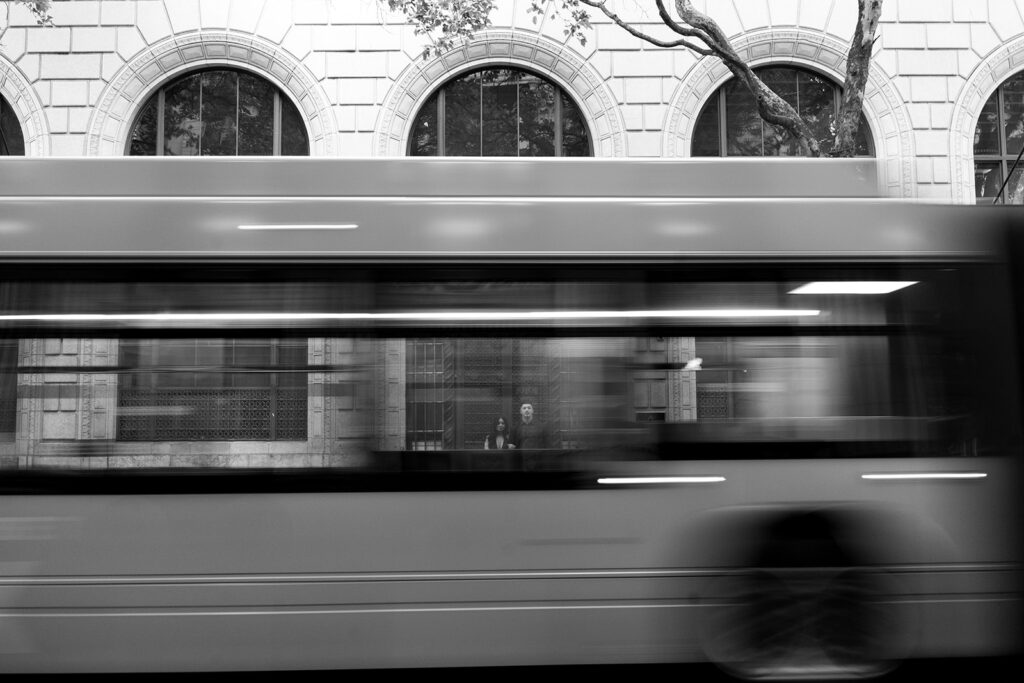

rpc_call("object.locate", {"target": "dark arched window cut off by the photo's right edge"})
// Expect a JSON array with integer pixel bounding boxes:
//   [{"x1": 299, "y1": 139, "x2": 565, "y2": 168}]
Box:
[{"x1": 974, "y1": 72, "x2": 1024, "y2": 204}]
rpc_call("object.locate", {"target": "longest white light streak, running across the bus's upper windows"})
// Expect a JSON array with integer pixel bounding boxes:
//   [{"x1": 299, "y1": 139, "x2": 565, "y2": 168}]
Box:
[{"x1": 0, "y1": 308, "x2": 821, "y2": 323}]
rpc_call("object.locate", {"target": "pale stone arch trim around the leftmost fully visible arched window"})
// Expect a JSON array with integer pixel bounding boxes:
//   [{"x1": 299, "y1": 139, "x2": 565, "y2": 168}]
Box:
[{"x1": 85, "y1": 31, "x2": 338, "y2": 157}]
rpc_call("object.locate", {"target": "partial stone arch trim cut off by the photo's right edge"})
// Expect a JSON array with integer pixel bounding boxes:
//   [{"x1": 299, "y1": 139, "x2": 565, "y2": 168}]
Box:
[{"x1": 949, "y1": 37, "x2": 1024, "y2": 204}]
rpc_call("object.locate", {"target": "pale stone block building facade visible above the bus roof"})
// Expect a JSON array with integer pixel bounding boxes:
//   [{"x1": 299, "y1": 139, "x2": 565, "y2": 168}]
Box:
[{"x1": 0, "y1": 0, "x2": 1024, "y2": 203}]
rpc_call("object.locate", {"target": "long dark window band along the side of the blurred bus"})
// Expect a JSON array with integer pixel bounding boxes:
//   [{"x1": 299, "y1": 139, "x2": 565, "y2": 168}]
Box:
[{"x1": 0, "y1": 264, "x2": 1007, "y2": 470}]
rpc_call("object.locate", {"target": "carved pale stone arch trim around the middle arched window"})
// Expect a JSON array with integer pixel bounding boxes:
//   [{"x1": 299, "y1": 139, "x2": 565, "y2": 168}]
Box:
[{"x1": 374, "y1": 31, "x2": 627, "y2": 157}]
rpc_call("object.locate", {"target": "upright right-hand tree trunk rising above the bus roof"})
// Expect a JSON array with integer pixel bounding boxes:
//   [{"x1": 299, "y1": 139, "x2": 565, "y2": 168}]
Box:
[{"x1": 829, "y1": 0, "x2": 882, "y2": 157}]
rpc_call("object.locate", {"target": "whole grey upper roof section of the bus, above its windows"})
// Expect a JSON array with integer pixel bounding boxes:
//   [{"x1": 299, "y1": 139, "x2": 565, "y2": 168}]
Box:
[{"x1": 0, "y1": 159, "x2": 1010, "y2": 260}]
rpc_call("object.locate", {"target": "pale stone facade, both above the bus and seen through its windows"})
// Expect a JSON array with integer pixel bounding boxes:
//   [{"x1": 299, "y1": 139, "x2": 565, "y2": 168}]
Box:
[{"x1": 0, "y1": 0, "x2": 1024, "y2": 466}]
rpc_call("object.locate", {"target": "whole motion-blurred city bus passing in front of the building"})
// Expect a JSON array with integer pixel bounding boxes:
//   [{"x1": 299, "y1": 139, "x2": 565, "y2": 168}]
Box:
[{"x1": 0, "y1": 159, "x2": 1024, "y2": 679}]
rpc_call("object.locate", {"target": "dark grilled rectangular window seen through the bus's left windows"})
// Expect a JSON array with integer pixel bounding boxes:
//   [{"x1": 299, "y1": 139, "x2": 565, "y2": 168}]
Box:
[{"x1": 117, "y1": 339, "x2": 308, "y2": 441}]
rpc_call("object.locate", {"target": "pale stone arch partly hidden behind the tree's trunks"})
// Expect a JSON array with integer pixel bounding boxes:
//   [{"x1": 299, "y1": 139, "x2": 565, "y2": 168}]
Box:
[{"x1": 663, "y1": 30, "x2": 915, "y2": 197}]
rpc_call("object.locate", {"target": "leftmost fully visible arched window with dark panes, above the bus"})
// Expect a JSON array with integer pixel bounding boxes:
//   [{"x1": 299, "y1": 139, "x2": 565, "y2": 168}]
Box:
[{"x1": 128, "y1": 69, "x2": 309, "y2": 157}]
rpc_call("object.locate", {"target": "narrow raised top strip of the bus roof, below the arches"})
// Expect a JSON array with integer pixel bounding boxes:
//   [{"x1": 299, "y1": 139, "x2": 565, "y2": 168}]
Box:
[{"x1": 0, "y1": 157, "x2": 880, "y2": 198}]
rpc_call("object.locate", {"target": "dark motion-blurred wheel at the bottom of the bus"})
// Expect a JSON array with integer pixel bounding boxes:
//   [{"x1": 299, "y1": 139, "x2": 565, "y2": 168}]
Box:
[{"x1": 701, "y1": 569, "x2": 895, "y2": 681}]
